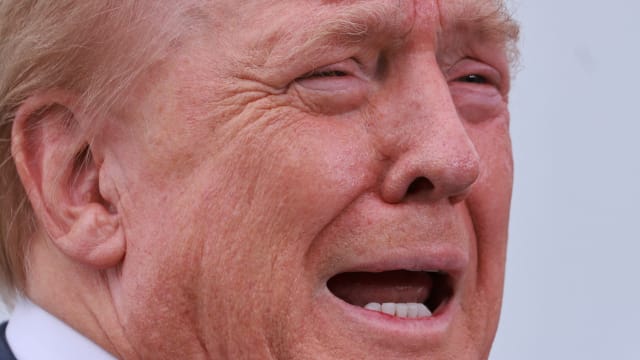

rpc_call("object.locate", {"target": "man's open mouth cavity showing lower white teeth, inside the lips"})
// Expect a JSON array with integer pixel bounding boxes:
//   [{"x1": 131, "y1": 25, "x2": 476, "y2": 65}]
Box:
[{"x1": 327, "y1": 270, "x2": 453, "y2": 319}]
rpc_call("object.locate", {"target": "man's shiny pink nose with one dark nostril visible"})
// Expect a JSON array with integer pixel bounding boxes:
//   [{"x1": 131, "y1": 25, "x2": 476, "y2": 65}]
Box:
[{"x1": 380, "y1": 61, "x2": 480, "y2": 203}]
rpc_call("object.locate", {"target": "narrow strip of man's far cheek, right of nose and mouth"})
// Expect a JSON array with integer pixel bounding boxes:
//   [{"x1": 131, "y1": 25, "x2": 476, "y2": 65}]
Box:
[{"x1": 452, "y1": 115, "x2": 513, "y2": 351}]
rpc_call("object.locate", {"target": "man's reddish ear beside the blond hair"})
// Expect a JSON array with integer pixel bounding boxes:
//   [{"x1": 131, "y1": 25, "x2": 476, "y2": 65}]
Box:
[{"x1": 11, "y1": 90, "x2": 126, "y2": 269}]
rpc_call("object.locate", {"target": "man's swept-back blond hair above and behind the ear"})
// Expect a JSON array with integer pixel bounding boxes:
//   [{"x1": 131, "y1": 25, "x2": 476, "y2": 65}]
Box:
[{"x1": 0, "y1": 0, "x2": 195, "y2": 304}]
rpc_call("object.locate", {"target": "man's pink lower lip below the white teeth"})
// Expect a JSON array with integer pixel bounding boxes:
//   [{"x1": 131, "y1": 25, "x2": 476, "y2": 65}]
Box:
[{"x1": 326, "y1": 289, "x2": 459, "y2": 341}]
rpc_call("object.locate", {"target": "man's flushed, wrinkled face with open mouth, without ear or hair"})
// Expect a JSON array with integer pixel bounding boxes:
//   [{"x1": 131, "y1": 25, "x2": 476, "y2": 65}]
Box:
[{"x1": 103, "y1": 0, "x2": 512, "y2": 359}]
